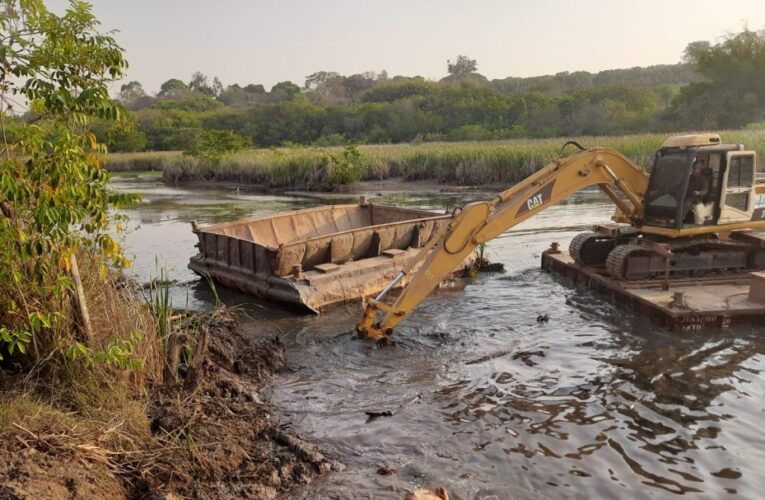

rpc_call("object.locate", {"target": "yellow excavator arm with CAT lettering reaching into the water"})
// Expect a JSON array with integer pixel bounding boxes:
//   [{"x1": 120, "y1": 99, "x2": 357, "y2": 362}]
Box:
[{"x1": 356, "y1": 148, "x2": 648, "y2": 344}]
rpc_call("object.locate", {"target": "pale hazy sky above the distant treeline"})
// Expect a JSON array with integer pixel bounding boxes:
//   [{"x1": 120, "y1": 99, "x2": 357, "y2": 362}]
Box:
[{"x1": 48, "y1": 0, "x2": 765, "y2": 92}]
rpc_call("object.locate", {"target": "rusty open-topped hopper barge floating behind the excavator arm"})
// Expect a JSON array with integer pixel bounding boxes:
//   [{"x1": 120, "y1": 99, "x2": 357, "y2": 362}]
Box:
[{"x1": 189, "y1": 197, "x2": 475, "y2": 312}]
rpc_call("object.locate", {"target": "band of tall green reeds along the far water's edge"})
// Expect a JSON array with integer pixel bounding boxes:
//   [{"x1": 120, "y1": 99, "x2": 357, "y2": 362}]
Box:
[{"x1": 109, "y1": 127, "x2": 765, "y2": 189}]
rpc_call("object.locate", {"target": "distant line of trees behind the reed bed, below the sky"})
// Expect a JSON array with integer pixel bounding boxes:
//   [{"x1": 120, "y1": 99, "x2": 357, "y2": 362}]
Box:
[{"x1": 86, "y1": 30, "x2": 765, "y2": 151}]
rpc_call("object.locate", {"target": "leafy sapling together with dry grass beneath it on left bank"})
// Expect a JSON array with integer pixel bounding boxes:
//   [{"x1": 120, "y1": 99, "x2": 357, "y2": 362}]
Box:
[{"x1": 0, "y1": 0, "x2": 162, "y2": 476}]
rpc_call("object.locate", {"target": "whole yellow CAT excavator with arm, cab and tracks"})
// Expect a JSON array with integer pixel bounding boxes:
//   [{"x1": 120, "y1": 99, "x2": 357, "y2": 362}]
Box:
[{"x1": 356, "y1": 134, "x2": 765, "y2": 345}]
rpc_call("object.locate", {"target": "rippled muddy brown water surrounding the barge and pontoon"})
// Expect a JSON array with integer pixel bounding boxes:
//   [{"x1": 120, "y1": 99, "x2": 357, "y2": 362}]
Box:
[{"x1": 113, "y1": 174, "x2": 765, "y2": 499}]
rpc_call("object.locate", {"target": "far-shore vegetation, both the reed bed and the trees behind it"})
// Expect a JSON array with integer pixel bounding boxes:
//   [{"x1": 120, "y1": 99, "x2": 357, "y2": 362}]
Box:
[{"x1": 96, "y1": 30, "x2": 765, "y2": 199}]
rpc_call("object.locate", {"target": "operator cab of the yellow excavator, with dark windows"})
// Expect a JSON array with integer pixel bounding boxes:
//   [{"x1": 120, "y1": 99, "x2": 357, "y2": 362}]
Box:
[{"x1": 644, "y1": 134, "x2": 760, "y2": 229}]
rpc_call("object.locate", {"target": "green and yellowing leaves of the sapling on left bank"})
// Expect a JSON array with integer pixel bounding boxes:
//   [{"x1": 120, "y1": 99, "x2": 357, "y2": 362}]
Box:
[{"x1": 0, "y1": 0, "x2": 128, "y2": 368}]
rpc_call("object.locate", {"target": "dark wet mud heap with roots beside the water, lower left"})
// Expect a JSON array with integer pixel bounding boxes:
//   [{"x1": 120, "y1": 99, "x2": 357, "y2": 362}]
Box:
[{"x1": 140, "y1": 313, "x2": 334, "y2": 499}]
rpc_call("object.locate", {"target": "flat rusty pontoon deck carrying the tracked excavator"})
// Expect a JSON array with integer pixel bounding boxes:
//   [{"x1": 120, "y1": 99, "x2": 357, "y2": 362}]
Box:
[{"x1": 542, "y1": 244, "x2": 765, "y2": 331}]
